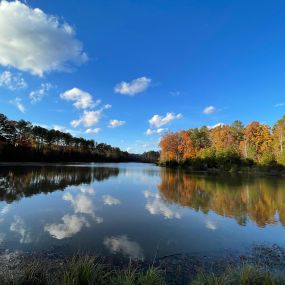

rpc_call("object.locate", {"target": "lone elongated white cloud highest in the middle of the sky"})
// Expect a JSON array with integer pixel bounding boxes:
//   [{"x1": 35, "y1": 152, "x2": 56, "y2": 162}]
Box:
[{"x1": 114, "y1": 76, "x2": 151, "y2": 96}]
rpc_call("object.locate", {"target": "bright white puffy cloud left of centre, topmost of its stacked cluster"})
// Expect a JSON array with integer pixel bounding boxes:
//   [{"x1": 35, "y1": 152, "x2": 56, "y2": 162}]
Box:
[{"x1": 60, "y1": 87, "x2": 97, "y2": 109}]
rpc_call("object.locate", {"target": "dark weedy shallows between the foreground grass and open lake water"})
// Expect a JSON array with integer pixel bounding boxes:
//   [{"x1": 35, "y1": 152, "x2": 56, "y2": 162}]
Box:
[{"x1": 0, "y1": 244, "x2": 285, "y2": 285}]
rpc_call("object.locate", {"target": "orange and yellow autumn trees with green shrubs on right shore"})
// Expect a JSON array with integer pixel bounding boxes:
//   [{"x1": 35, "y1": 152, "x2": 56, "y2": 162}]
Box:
[{"x1": 160, "y1": 116, "x2": 285, "y2": 171}]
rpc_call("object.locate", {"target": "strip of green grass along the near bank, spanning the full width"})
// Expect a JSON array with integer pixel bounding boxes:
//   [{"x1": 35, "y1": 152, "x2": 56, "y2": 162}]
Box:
[{"x1": 0, "y1": 251, "x2": 285, "y2": 285}]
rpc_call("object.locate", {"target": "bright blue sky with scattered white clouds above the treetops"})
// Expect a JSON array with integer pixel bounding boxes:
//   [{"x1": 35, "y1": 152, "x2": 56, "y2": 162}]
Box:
[{"x1": 0, "y1": 0, "x2": 285, "y2": 152}]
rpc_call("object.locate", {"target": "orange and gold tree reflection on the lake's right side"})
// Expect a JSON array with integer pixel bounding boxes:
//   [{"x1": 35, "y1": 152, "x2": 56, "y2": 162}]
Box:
[{"x1": 158, "y1": 170, "x2": 285, "y2": 227}]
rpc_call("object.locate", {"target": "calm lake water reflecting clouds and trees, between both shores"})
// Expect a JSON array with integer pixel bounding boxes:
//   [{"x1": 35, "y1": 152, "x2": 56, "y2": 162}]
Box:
[{"x1": 0, "y1": 163, "x2": 285, "y2": 259}]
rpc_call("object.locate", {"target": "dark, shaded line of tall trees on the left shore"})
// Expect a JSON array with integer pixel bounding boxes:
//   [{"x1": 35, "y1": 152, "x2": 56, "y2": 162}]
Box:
[{"x1": 0, "y1": 114, "x2": 159, "y2": 162}]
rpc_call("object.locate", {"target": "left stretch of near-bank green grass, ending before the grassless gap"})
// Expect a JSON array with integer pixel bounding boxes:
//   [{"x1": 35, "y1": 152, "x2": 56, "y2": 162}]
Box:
[{"x1": 0, "y1": 255, "x2": 166, "y2": 285}]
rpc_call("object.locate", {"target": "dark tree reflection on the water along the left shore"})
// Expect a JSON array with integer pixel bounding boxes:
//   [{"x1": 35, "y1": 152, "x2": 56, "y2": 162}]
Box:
[{"x1": 0, "y1": 166, "x2": 119, "y2": 203}]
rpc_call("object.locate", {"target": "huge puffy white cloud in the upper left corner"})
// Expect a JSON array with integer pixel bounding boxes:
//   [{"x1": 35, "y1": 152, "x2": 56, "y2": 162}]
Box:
[{"x1": 0, "y1": 0, "x2": 87, "y2": 76}]
